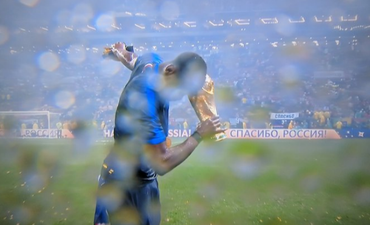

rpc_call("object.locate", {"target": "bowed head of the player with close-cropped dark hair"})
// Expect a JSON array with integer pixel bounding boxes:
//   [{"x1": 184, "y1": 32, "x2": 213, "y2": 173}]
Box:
[{"x1": 173, "y1": 52, "x2": 207, "y2": 92}]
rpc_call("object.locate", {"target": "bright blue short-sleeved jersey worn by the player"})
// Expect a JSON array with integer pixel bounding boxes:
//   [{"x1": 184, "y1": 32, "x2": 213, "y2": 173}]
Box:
[{"x1": 114, "y1": 53, "x2": 169, "y2": 180}]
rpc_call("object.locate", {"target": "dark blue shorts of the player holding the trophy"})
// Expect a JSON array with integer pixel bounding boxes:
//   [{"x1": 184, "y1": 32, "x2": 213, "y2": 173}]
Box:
[{"x1": 94, "y1": 173, "x2": 161, "y2": 225}]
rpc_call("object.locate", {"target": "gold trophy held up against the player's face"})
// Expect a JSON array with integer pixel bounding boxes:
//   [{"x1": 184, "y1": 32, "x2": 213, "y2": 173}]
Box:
[{"x1": 189, "y1": 74, "x2": 226, "y2": 141}]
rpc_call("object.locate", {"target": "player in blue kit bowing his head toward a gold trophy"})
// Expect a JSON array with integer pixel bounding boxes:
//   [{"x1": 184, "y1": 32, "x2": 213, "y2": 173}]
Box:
[{"x1": 94, "y1": 43, "x2": 224, "y2": 225}]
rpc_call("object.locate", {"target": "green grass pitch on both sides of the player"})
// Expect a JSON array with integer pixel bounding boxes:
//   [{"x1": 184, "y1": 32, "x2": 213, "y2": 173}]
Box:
[{"x1": 0, "y1": 139, "x2": 370, "y2": 225}]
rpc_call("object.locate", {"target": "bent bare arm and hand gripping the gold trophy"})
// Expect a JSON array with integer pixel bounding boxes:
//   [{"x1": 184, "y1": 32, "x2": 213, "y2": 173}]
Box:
[{"x1": 145, "y1": 117, "x2": 225, "y2": 176}]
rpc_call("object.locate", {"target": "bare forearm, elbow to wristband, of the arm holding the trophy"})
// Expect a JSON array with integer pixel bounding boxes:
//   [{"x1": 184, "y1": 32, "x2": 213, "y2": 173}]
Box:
[{"x1": 157, "y1": 137, "x2": 199, "y2": 175}]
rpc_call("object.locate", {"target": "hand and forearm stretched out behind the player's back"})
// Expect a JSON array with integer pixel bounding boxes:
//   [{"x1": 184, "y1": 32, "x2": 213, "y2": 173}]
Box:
[{"x1": 103, "y1": 42, "x2": 138, "y2": 70}]
